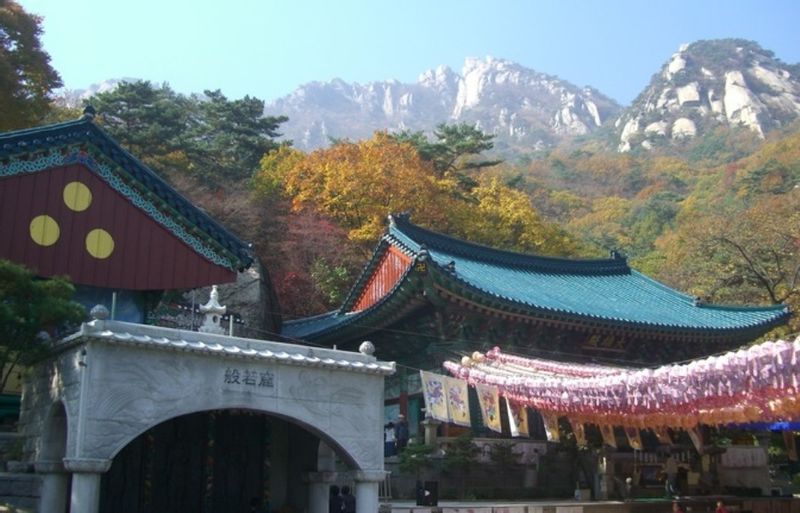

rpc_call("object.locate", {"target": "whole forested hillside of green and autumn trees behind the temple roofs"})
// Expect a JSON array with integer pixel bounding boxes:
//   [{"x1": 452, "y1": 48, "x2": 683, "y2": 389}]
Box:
[{"x1": 0, "y1": 2, "x2": 800, "y2": 331}]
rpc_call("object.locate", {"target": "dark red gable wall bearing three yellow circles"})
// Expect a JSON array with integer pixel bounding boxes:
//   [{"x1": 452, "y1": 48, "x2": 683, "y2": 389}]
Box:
[{"x1": 0, "y1": 164, "x2": 236, "y2": 290}]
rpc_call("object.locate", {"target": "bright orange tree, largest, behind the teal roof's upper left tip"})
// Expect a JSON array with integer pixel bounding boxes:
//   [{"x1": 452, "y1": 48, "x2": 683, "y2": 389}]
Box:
[{"x1": 256, "y1": 132, "x2": 462, "y2": 245}]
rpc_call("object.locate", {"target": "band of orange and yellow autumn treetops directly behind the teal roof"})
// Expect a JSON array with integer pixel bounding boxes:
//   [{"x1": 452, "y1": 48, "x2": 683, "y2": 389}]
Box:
[{"x1": 256, "y1": 132, "x2": 576, "y2": 255}]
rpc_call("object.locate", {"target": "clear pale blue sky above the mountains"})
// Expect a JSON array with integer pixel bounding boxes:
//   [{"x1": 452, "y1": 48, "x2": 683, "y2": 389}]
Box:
[{"x1": 18, "y1": 0, "x2": 800, "y2": 105}]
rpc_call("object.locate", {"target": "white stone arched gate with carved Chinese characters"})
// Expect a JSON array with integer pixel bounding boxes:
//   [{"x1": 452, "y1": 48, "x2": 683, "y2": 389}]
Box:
[{"x1": 20, "y1": 312, "x2": 395, "y2": 513}]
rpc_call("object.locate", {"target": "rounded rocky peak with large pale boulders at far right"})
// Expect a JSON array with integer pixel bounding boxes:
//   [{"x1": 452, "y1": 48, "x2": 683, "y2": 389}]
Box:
[{"x1": 615, "y1": 39, "x2": 800, "y2": 151}]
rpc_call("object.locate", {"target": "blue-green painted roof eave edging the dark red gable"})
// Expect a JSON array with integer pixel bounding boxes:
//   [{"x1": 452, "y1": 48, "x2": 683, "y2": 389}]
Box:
[{"x1": 0, "y1": 115, "x2": 253, "y2": 271}]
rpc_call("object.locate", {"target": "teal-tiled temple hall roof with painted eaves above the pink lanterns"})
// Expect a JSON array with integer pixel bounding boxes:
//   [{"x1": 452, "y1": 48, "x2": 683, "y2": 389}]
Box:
[{"x1": 283, "y1": 215, "x2": 789, "y2": 428}]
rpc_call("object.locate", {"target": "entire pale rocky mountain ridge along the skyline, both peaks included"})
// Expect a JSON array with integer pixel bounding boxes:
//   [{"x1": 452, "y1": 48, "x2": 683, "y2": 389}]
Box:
[{"x1": 57, "y1": 39, "x2": 800, "y2": 155}]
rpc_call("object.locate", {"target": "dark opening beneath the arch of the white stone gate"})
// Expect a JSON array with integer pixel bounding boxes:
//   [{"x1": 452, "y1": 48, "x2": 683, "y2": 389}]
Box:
[{"x1": 100, "y1": 409, "x2": 357, "y2": 512}]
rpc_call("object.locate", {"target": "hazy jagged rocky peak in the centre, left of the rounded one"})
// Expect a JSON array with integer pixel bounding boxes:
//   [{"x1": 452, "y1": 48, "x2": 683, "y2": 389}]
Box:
[{"x1": 266, "y1": 57, "x2": 620, "y2": 150}]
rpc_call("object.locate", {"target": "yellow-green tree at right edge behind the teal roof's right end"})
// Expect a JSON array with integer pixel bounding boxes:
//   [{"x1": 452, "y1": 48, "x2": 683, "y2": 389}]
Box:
[{"x1": 658, "y1": 188, "x2": 800, "y2": 329}]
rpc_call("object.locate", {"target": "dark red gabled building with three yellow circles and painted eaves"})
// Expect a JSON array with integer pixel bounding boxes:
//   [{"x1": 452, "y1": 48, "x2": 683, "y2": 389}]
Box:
[{"x1": 0, "y1": 107, "x2": 260, "y2": 322}]
